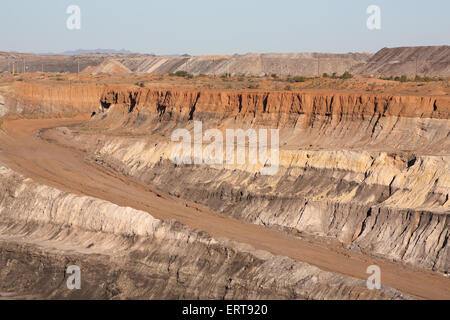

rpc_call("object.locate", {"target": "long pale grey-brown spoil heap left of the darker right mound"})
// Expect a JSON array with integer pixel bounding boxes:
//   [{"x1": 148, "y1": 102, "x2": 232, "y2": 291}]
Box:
[{"x1": 0, "y1": 52, "x2": 370, "y2": 76}]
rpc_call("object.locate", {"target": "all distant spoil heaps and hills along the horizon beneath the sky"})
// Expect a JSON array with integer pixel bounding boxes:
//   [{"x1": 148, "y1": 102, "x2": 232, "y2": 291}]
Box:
[{"x1": 0, "y1": 45, "x2": 450, "y2": 76}]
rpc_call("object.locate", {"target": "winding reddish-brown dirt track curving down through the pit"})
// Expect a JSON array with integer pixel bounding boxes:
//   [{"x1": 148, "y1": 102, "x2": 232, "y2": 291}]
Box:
[{"x1": 0, "y1": 116, "x2": 450, "y2": 299}]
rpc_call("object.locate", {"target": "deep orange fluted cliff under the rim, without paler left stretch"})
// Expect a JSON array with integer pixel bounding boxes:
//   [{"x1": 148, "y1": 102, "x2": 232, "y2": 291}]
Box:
[{"x1": 101, "y1": 87, "x2": 450, "y2": 119}]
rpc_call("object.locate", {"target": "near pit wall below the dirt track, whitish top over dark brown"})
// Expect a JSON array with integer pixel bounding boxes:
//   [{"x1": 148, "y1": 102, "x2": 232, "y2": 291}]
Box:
[{"x1": 0, "y1": 165, "x2": 404, "y2": 299}]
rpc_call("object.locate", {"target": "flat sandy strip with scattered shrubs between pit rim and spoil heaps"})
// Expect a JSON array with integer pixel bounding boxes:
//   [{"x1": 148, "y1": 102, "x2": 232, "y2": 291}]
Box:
[{"x1": 0, "y1": 73, "x2": 450, "y2": 96}]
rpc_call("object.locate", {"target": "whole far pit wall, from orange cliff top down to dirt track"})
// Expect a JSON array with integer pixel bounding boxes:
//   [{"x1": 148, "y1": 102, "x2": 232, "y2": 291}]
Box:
[{"x1": 80, "y1": 88, "x2": 450, "y2": 273}]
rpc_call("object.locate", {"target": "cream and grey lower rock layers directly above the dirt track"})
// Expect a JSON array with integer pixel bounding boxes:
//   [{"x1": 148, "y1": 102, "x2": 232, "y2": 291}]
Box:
[{"x1": 80, "y1": 145, "x2": 450, "y2": 273}]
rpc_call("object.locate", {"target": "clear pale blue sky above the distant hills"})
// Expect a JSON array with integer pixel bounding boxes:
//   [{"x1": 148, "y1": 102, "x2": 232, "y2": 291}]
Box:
[{"x1": 0, "y1": 0, "x2": 450, "y2": 55}]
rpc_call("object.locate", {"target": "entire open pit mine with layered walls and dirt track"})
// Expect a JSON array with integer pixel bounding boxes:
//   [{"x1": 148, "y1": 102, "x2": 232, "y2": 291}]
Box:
[{"x1": 0, "y1": 74, "x2": 450, "y2": 299}]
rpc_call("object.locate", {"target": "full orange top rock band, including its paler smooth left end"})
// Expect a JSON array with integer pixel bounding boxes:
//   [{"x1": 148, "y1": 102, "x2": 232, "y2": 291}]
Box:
[{"x1": 6, "y1": 83, "x2": 450, "y2": 119}]
